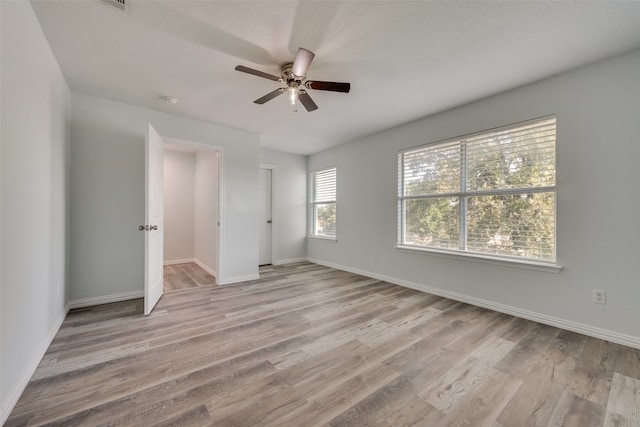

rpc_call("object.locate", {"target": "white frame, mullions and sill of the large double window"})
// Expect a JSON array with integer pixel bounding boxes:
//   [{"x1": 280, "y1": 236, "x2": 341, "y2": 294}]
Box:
[{"x1": 396, "y1": 115, "x2": 562, "y2": 272}]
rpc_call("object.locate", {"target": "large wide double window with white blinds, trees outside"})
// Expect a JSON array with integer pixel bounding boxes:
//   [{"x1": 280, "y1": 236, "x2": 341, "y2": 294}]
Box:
[{"x1": 398, "y1": 117, "x2": 556, "y2": 262}]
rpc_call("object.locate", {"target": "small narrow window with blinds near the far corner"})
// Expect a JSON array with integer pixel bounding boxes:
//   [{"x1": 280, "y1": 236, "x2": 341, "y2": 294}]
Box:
[{"x1": 309, "y1": 167, "x2": 336, "y2": 238}]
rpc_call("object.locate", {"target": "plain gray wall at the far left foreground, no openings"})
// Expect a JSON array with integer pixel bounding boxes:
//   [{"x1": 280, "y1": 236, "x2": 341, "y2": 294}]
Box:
[{"x1": 0, "y1": 1, "x2": 71, "y2": 424}]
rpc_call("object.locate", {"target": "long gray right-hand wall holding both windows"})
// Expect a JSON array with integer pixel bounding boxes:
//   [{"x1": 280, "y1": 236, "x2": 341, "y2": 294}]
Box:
[{"x1": 307, "y1": 51, "x2": 640, "y2": 347}]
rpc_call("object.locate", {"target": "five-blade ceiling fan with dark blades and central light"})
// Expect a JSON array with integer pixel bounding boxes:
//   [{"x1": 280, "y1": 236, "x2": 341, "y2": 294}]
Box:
[{"x1": 235, "y1": 47, "x2": 351, "y2": 111}]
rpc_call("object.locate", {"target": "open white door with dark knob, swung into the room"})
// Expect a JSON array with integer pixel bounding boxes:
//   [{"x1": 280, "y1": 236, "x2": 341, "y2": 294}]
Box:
[{"x1": 144, "y1": 124, "x2": 164, "y2": 316}]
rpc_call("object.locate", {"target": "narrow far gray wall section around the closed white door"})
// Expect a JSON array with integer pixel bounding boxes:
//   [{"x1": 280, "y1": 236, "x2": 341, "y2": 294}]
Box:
[{"x1": 260, "y1": 149, "x2": 307, "y2": 264}]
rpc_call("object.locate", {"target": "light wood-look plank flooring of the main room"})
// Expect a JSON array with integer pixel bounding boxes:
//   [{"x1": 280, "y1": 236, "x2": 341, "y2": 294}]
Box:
[{"x1": 6, "y1": 263, "x2": 640, "y2": 427}]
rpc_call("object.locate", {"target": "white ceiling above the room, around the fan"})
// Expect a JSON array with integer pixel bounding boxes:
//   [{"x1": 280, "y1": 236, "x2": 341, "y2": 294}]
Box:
[{"x1": 32, "y1": 0, "x2": 640, "y2": 154}]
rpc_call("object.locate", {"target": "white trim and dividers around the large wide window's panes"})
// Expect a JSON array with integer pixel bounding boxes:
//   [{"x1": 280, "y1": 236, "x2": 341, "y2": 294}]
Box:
[{"x1": 395, "y1": 114, "x2": 562, "y2": 266}]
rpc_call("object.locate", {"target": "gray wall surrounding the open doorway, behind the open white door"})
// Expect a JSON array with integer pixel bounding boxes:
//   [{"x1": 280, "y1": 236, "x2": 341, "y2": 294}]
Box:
[{"x1": 70, "y1": 93, "x2": 259, "y2": 300}]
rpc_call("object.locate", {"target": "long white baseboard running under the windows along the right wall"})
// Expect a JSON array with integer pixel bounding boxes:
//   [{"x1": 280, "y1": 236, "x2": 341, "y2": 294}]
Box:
[{"x1": 307, "y1": 257, "x2": 640, "y2": 349}]
